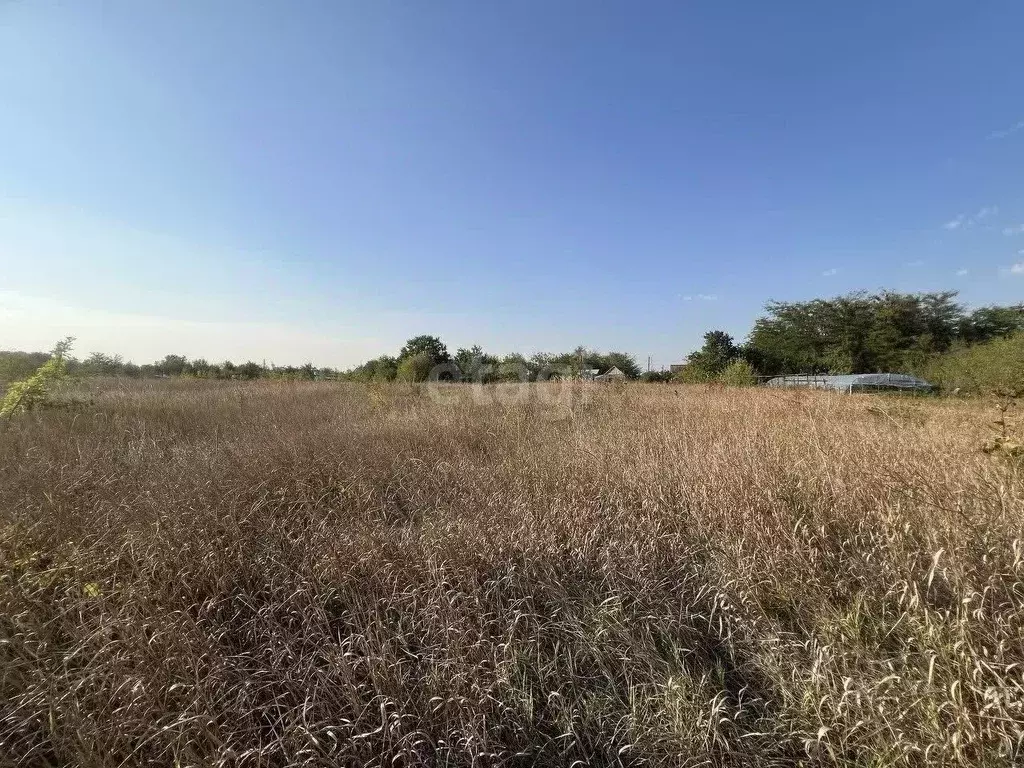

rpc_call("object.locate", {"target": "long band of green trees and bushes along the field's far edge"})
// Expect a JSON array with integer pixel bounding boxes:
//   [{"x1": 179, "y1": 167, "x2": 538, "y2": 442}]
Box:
[{"x1": 0, "y1": 291, "x2": 1024, "y2": 391}]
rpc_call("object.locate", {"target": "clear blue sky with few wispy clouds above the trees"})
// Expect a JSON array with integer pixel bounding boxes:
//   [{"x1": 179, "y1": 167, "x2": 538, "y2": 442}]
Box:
[{"x1": 0, "y1": 0, "x2": 1024, "y2": 367}]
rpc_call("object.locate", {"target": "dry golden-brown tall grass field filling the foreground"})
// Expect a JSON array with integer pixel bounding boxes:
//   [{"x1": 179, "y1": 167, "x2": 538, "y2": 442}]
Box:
[{"x1": 0, "y1": 381, "x2": 1024, "y2": 767}]
